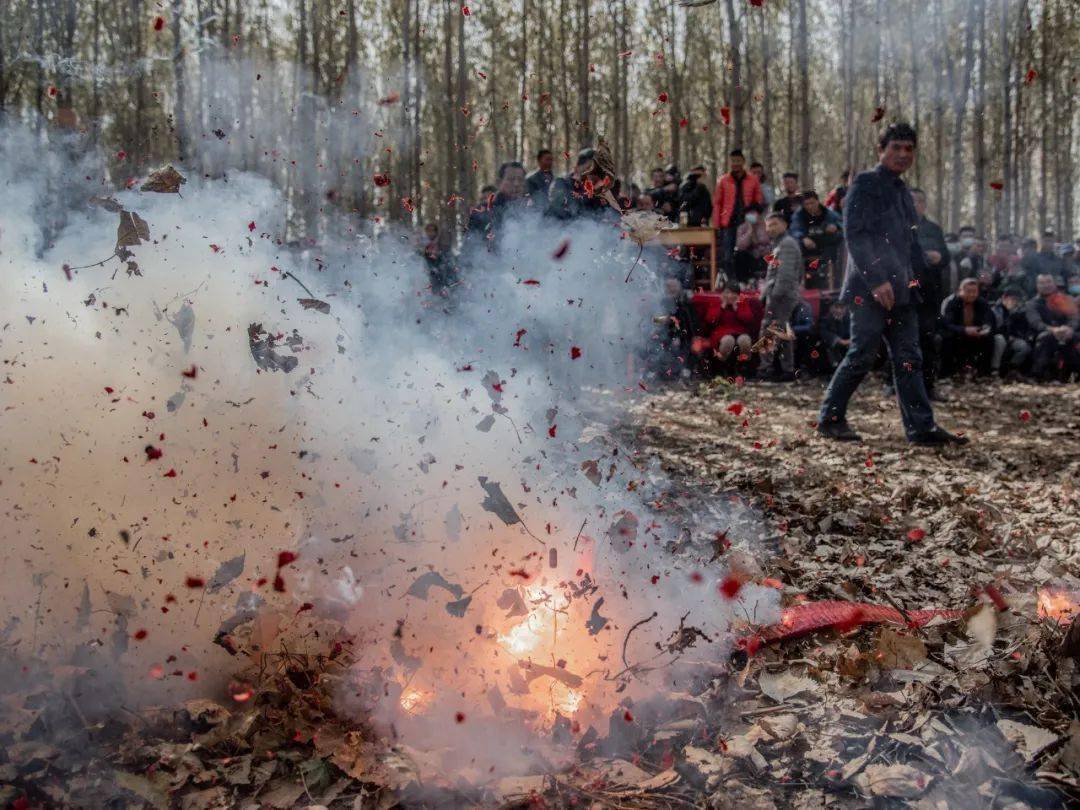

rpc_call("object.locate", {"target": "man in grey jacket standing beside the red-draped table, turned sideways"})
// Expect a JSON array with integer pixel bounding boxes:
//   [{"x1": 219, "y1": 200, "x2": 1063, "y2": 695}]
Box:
[{"x1": 761, "y1": 212, "x2": 802, "y2": 381}]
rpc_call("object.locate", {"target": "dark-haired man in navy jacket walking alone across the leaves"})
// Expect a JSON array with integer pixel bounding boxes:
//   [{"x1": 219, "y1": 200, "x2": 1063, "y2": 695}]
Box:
[{"x1": 818, "y1": 123, "x2": 968, "y2": 445}]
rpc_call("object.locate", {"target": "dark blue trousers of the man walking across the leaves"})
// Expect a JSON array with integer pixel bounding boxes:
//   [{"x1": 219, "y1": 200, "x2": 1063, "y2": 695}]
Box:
[{"x1": 819, "y1": 301, "x2": 934, "y2": 440}]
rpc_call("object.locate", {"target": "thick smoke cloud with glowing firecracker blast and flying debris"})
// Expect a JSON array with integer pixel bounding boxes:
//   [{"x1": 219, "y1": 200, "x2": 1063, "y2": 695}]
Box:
[{"x1": 0, "y1": 118, "x2": 778, "y2": 772}]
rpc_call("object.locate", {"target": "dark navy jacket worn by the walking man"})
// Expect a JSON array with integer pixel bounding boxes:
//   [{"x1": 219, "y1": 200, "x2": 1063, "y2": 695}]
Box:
[{"x1": 840, "y1": 164, "x2": 926, "y2": 305}]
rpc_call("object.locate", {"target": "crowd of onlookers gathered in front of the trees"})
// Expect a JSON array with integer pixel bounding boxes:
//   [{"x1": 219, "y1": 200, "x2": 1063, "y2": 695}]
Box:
[{"x1": 420, "y1": 142, "x2": 1080, "y2": 390}]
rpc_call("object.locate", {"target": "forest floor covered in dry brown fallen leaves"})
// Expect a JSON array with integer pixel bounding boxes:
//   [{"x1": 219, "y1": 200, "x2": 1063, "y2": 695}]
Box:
[{"x1": 0, "y1": 380, "x2": 1080, "y2": 810}]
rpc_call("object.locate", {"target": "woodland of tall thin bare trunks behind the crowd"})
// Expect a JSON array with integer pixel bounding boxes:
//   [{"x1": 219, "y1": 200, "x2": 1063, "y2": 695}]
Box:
[{"x1": 0, "y1": 0, "x2": 1080, "y2": 246}]
